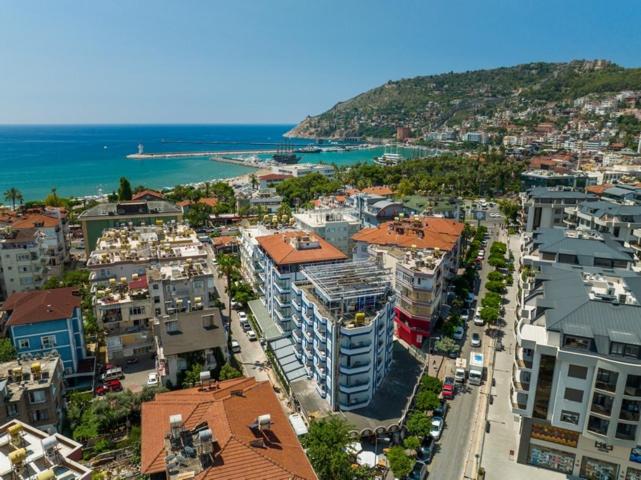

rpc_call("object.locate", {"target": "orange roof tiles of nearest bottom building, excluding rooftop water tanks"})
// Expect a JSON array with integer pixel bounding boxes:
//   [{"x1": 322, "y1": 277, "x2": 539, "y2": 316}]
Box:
[{"x1": 141, "y1": 378, "x2": 317, "y2": 480}]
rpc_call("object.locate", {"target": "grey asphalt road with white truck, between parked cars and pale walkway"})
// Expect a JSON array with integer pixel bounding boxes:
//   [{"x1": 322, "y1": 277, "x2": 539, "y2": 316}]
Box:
[{"x1": 428, "y1": 218, "x2": 502, "y2": 480}]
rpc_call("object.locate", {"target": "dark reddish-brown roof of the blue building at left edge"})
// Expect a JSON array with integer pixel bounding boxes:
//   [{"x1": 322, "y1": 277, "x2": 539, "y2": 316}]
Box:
[{"x1": 2, "y1": 287, "x2": 80, "y2": 325}]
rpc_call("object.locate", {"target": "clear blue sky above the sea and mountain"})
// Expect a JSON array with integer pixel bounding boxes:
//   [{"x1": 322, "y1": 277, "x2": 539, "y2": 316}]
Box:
[{"x1": 0, "y1": 0, "x2": 641, "y2": 124}]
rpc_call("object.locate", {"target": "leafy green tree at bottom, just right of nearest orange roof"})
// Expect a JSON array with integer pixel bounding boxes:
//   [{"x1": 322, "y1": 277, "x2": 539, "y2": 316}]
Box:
[{"x1": 302, "y1": 416, "x2": 352, "y2": 480}]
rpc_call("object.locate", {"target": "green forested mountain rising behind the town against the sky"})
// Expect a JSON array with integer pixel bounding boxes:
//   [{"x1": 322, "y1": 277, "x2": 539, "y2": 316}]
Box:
[{"x1": 286, "y1": 60, "x2": 641, "y2": 138}]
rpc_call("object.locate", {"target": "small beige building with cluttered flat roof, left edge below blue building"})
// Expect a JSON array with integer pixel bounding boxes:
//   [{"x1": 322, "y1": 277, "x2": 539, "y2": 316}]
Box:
[{"x1": 0, "y1": 354, "x2": 64, "y2": 432}]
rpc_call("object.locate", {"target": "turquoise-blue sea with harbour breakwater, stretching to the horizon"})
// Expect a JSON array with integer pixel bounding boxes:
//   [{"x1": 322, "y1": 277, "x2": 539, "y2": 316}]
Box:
[{"x1": 0, "y1": 125, "x2": 390, "y2": 204}]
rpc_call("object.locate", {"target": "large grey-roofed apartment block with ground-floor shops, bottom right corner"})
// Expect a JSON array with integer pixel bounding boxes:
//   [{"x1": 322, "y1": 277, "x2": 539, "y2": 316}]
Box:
[{"x1": 511, "y1": 265, "x2": 641, "y2": 478}]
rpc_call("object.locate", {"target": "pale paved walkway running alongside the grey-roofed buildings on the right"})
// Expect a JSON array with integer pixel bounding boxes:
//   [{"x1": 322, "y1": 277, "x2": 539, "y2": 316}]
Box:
[{"x1": 474, "y1": 235, "x2": 566, "y2": 480}]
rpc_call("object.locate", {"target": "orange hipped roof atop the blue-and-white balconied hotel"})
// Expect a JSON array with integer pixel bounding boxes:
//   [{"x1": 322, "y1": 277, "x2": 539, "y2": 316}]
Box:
[{"x1": 256, "y1": 232, "x2": 347, "y2": 265}]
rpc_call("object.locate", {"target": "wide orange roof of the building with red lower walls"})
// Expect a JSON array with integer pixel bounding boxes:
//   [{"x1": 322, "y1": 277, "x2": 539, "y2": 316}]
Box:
[{"x1": 352, "y1": 217, "x2": 463, "y2": 250}]
